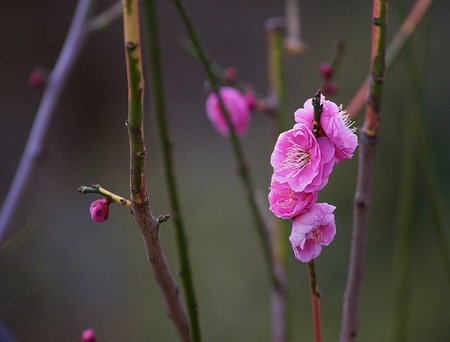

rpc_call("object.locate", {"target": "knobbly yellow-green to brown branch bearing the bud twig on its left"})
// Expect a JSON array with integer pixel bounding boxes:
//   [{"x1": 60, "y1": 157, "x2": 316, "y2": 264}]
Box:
[{"x1": 122, "y1": 0, "x2": 190, "y2": 341}]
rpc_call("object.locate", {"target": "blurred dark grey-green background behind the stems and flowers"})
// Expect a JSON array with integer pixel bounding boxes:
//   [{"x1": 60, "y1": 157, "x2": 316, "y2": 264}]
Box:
[{"x1": 0, "y1": 0, "x2": 450, "y2": 341}]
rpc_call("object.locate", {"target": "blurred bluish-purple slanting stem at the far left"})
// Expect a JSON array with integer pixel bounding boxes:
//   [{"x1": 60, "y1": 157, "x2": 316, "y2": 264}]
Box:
[{"x1": 0, "y1": 0, "x2": 94, "y2": 245}]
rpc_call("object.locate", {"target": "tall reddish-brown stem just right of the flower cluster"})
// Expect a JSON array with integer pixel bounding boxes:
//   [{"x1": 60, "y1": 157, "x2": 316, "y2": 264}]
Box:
[{"x1": 340, "y1": 0, "x2": 388, "y2": 342}]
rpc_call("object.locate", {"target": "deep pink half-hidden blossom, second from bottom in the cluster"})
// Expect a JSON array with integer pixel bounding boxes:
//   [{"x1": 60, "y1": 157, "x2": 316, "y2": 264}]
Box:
[{"x1": 269, "y1": 178, "x2": 317, "y2": 219}]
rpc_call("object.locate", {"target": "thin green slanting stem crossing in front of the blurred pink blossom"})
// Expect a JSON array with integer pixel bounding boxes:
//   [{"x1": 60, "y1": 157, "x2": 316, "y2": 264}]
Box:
[{"x1": 172, "y1": 0, "x2": 280, "y2": 287}]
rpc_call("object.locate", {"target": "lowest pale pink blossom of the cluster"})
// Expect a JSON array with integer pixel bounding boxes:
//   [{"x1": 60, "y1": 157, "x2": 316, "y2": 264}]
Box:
[{"x1": 289, "y1": 203, "x2": 336, "y2": 262}]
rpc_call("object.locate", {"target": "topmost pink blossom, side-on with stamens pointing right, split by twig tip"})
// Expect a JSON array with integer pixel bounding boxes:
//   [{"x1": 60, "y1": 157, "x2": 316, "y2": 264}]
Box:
[{"x1": 294, "y1": 95, "x2": 358, "y2": 162}]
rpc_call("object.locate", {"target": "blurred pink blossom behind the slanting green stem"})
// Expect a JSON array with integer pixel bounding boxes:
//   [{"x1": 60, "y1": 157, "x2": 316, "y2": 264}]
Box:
[{"x1": 206, "y1": 87, "x2": 250, "y2": 136}]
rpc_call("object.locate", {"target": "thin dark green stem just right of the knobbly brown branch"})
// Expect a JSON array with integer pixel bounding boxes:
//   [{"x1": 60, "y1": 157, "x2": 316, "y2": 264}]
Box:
[{"x1": 144, "y1": 0, "x2": 201, "y2": 341}]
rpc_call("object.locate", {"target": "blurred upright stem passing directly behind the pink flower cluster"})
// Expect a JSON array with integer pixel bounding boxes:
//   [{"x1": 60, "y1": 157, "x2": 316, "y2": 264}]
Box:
[{"x1": 266, "y1": 18, "x2": 289, "y2": 342}]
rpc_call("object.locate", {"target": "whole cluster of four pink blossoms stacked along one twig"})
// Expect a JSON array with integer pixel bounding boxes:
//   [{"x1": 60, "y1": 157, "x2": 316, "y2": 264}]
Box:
[{"x1": 269, "y1": 95, "x2": 358, "y2": 262}]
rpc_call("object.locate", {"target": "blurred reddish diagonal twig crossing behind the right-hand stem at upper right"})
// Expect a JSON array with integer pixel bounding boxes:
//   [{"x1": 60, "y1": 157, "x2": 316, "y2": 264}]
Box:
[{"x1": 346, "y1": 0, "x2": 433, "y2": 119}]
